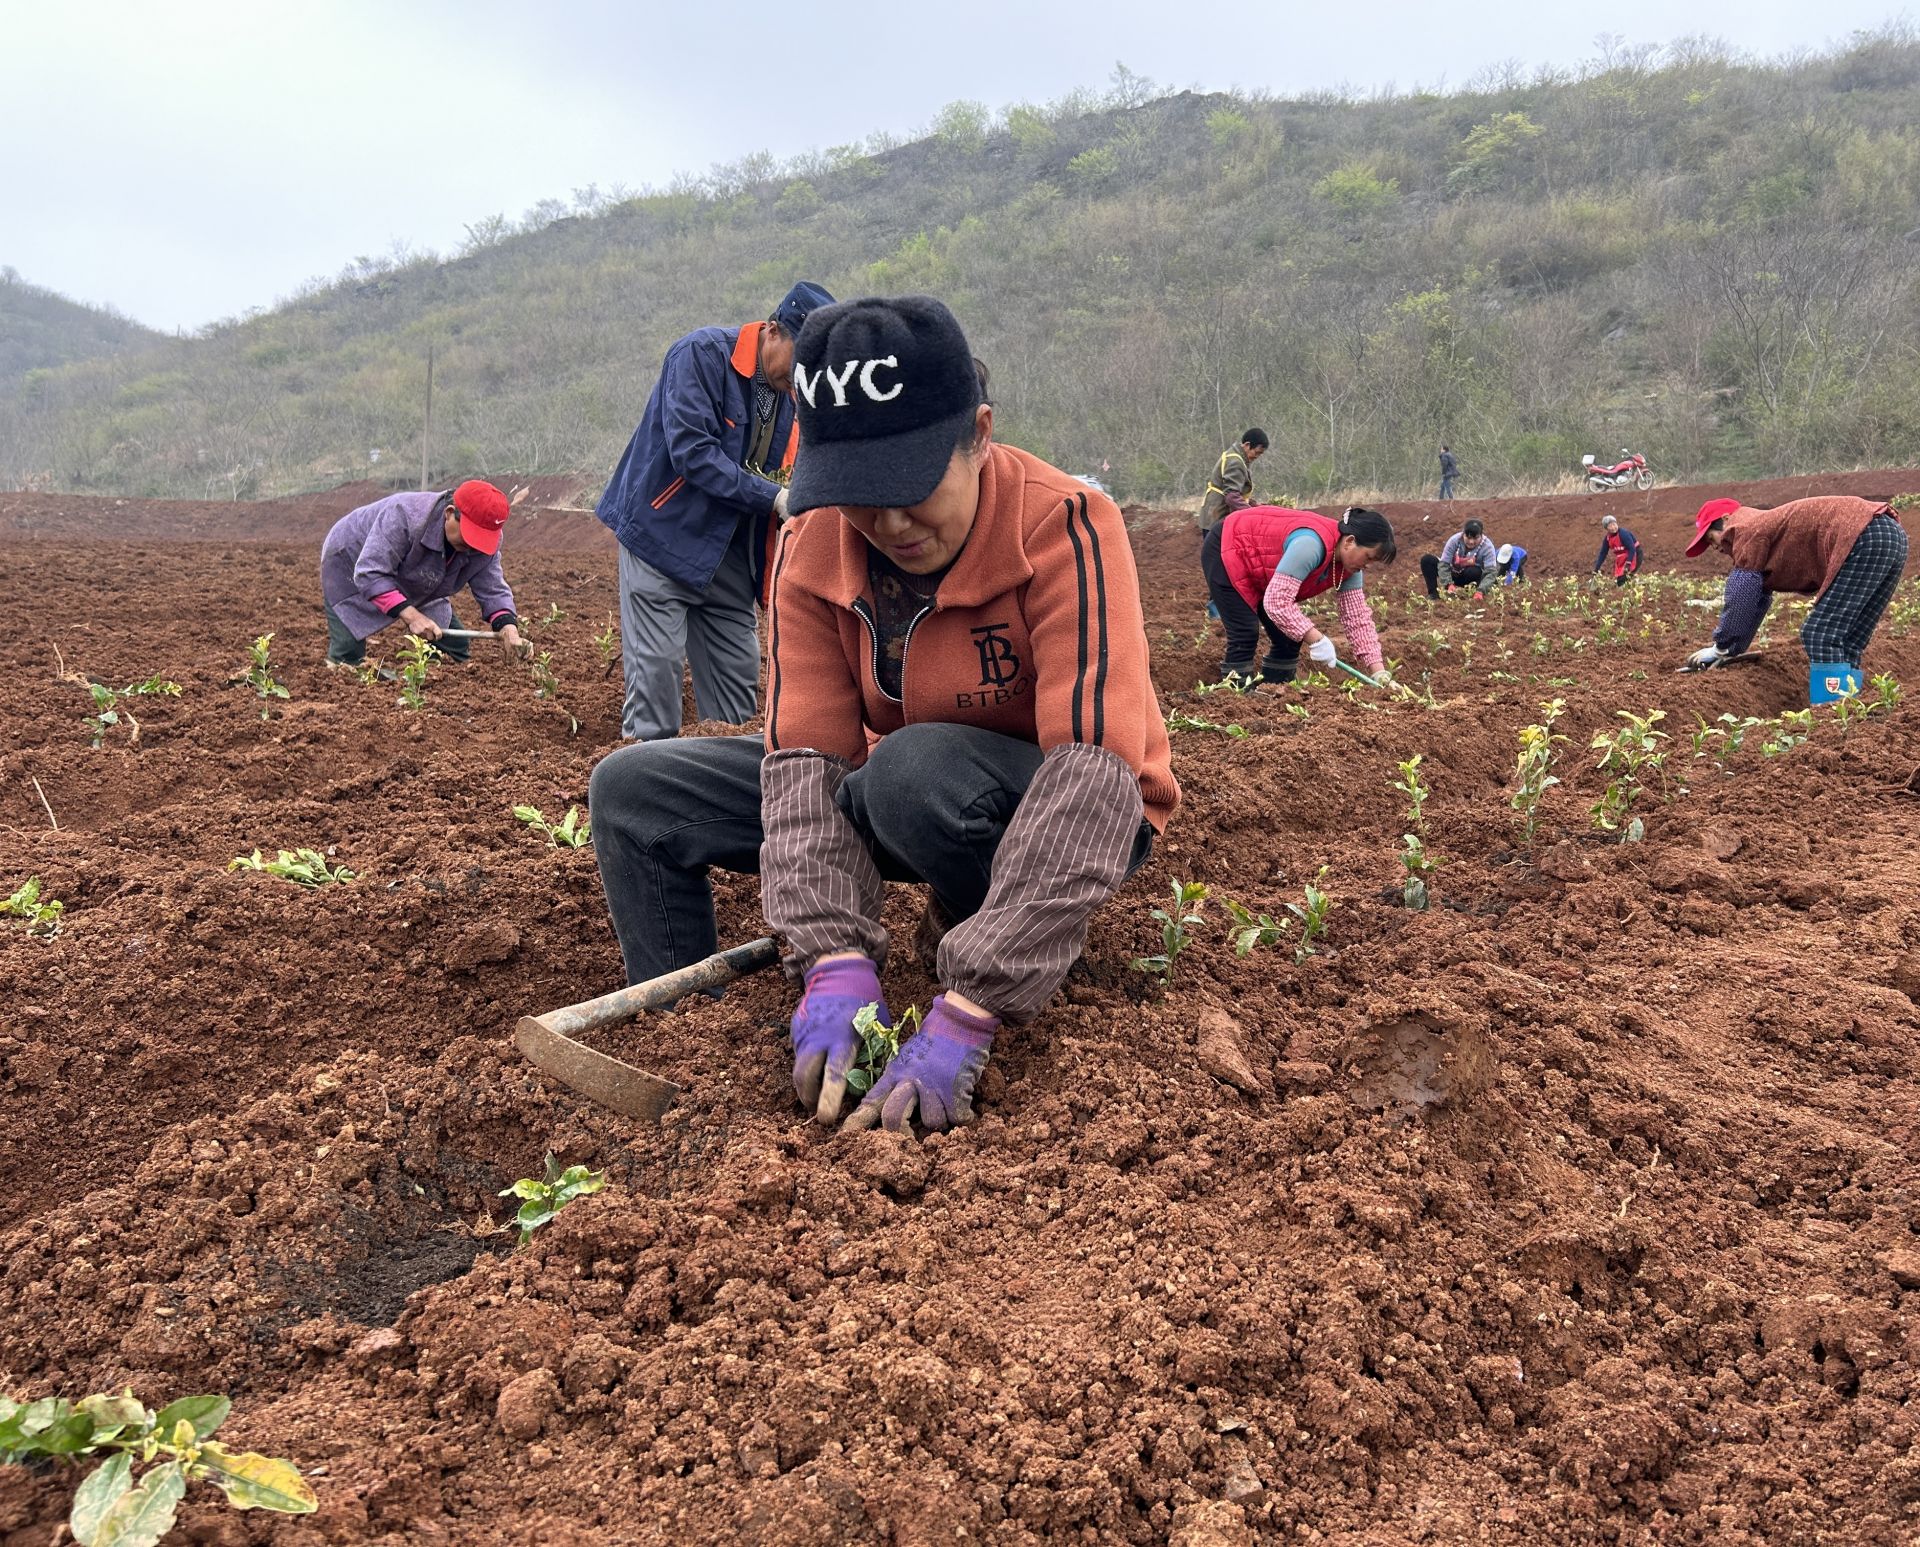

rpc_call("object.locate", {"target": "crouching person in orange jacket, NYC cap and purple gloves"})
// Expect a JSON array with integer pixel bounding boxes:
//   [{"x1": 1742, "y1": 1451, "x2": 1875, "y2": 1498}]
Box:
[{"x1": 589, "y1": 296, "x2": 1179, "y2": 1129}]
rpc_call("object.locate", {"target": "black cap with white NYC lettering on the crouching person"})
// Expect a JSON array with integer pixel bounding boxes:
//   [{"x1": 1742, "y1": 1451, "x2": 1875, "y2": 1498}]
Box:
[{"x1": 787, "y1": 296, "x2": 981, "y2": 514}]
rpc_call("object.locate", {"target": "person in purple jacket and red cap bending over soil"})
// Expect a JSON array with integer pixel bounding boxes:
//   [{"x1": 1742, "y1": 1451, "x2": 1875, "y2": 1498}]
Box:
[{"x1": 321, "y1": 478, "x2": 532, "y2": 666}]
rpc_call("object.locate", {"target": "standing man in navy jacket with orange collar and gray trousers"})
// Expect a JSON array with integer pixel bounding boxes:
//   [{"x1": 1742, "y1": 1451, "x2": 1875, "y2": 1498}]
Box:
[{"x1": 595, "y1": 280, "x2": 833, "y2": 741}]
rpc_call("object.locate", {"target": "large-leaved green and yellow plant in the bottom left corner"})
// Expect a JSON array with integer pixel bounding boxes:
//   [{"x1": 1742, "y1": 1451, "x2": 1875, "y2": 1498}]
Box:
[{"x1": 0, "y1": 1392, "x2": 319, "y2": 1547}]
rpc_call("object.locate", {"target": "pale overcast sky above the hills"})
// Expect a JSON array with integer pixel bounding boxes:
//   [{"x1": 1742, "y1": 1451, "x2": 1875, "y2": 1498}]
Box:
[{"x1": 0, "y1": 0, "x2": 1899, "y2": 328}]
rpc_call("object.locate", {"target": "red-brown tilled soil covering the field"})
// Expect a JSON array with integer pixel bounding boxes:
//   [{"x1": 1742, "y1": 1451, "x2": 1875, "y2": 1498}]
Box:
[{"x1": 0, "y1": 474, "x2": 1920, "y2": 1547}]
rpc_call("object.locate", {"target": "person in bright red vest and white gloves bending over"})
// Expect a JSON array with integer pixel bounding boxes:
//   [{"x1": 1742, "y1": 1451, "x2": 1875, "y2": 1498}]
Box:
[{"x1": 1200, "y1": 505, "x2": 1394, "y2": 683}]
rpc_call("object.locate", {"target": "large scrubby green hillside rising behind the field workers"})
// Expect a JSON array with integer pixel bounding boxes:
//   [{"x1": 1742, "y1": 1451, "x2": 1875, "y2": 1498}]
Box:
[{"x1": 0, "y1": 29, "x2": 1920, "y2": 499}]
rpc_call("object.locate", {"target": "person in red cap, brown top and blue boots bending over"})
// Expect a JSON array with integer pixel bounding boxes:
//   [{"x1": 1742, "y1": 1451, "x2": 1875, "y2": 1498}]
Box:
[{"x1": 1686, "y1": 495, "x2": 1907, "y2": 704}]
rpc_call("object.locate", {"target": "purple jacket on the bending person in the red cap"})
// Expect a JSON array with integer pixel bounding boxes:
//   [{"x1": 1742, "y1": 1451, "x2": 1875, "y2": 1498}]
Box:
[{"x1": 321, "y1": 489, "x2": 518, "y2": 639}]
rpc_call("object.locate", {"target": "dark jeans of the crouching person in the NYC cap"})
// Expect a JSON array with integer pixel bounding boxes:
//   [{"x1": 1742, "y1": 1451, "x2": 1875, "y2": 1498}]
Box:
[{"x1": 588, "y1": 726, "x2": 1154, "y2": 983}]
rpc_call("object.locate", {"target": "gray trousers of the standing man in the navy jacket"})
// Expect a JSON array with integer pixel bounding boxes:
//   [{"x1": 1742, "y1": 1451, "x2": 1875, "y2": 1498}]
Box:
[{"x1": 620, "y1": 520, "x2": 760, "y2": 741}]
